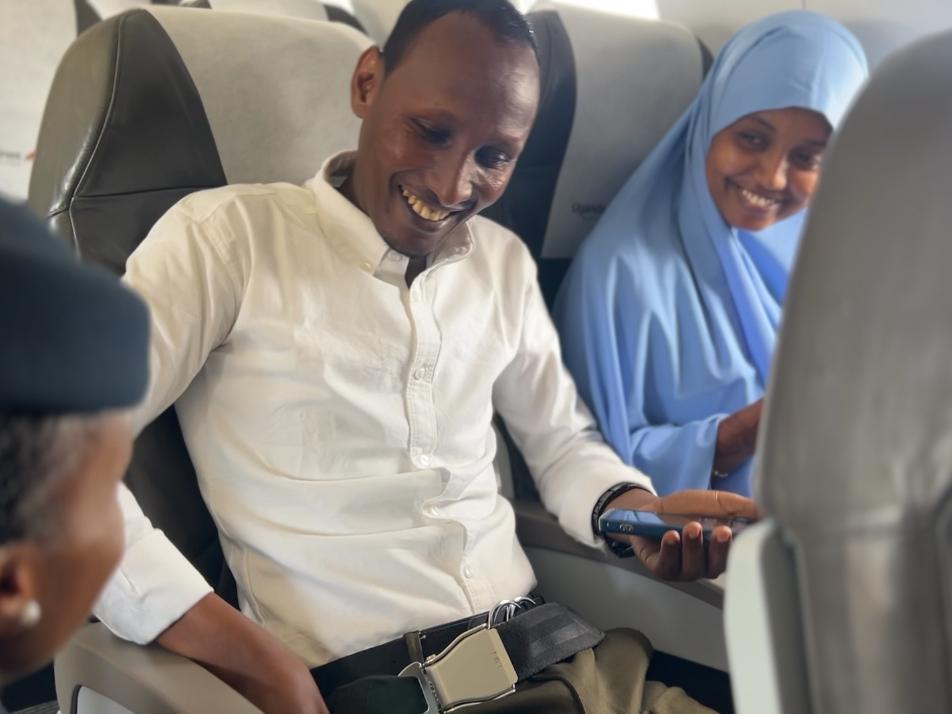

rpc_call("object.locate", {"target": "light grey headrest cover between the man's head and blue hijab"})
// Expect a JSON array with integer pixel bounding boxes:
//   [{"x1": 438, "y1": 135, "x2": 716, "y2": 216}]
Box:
[{"x1": 537, "y1": 2, "x2": 703, "y2": 258}]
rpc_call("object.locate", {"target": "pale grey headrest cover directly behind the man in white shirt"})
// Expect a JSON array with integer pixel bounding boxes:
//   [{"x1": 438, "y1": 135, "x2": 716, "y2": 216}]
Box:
[{"x1": 149, "y1": 6, "x2": 370, "y2": 183}]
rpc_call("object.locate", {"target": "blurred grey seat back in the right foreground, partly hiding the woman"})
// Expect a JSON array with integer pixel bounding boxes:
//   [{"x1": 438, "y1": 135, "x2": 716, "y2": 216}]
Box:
[{"x1": 725, "y1": 27, "x2": 952, "y2": 714}]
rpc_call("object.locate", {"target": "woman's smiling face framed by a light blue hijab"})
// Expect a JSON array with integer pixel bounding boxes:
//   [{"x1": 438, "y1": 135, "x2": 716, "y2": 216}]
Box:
[{"x1": 705, "y1": 107, "x2": 831, "y2": 231}]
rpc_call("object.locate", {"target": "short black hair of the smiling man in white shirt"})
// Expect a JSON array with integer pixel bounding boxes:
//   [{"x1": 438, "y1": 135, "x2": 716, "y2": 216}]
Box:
[{"x1": 383, "y1": 0, "x2": 539, "y2": 72}]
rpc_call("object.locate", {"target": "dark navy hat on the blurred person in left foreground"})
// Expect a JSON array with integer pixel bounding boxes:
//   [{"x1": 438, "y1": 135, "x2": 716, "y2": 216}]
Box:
[{"x1": 0, "y1": 200, "x2": 149, "y2": 413}]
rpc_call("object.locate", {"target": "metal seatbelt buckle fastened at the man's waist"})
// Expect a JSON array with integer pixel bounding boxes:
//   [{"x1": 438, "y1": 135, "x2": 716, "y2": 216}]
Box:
[{"x1": 400, "y1": 625, "x2": 518, "y2": 714}]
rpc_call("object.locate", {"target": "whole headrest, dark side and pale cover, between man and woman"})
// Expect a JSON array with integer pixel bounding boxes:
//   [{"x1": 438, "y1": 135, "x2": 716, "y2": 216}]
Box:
[{"x1": 486, "y1": 2, "x2": 703, "y2": 300}]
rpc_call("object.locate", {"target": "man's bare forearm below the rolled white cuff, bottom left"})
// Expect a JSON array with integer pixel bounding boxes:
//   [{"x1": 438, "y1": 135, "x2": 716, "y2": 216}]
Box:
[{"x1": 157, "y1": 594, "x2": 329, "y2": 714}]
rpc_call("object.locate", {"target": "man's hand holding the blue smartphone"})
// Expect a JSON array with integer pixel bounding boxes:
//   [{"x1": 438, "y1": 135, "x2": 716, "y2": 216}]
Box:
[{"x1": 605, "y1": 489, "x2": 758, "y2": 580}]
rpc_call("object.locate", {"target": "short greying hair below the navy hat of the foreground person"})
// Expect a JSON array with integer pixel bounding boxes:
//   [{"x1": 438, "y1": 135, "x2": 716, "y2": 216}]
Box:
[{"x1": 0, "y1": 413, "x2": 101, "y2": 545}]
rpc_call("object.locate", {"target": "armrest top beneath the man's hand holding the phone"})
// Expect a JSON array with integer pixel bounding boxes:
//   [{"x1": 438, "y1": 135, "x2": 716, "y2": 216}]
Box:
[{"x1": 512, "y1": 499, "x2": 724, "y2": 609}]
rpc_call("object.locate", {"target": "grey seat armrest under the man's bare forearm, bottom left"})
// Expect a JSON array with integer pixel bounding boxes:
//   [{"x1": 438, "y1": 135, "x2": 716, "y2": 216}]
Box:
[{"x1": 54, "y1": 623, "x2": 261, "y2": 714}]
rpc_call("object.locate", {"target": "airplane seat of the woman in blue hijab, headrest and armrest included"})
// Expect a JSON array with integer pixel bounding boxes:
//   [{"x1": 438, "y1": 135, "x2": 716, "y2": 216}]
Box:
[{"x1": 485, "y1": 2, "x2": 727, "y2": 671}]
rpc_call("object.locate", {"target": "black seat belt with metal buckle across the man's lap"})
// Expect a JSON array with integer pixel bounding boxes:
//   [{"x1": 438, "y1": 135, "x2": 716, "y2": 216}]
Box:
[{"x1": 328, "y1": 603, "x2": 605, "y2": 714}]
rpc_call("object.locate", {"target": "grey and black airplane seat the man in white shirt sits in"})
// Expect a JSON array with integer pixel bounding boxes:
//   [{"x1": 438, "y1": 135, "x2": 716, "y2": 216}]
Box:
[{"x1": 29, "y1": 6, "x2": 369, "y2": 714}]
